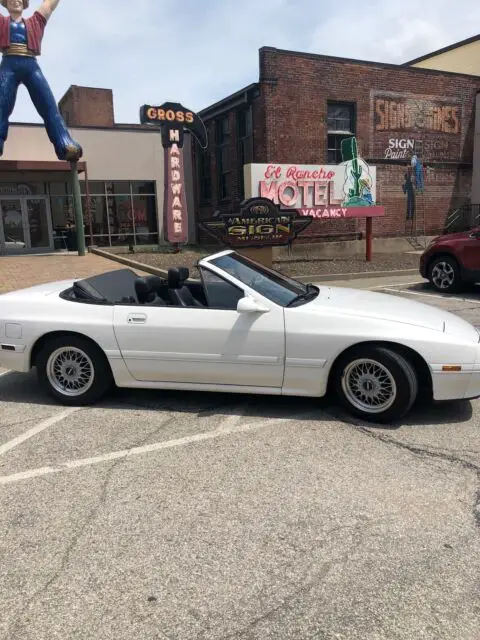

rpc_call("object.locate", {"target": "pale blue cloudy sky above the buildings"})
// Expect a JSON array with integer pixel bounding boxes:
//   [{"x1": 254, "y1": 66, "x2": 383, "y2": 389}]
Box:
[{"x1": 1, "y1": 0, "x2": 480, "y2": 123}]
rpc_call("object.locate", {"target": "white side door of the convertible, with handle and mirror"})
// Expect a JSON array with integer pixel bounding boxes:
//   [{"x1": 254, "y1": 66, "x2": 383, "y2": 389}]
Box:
[{"x1": 114, "y1": 270, "x2": 285, "y2": 388}]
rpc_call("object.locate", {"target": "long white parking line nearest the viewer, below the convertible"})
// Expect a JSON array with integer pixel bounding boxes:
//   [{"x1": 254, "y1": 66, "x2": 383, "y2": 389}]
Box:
[{"x1": 0, "y1": 412, "x2": 313, "y2": 485}]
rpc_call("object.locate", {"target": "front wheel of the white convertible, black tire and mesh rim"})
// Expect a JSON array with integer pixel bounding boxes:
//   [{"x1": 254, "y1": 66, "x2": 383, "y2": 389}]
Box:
[{"x1": 333, "y1": 345, "x2": 418, "y2": 424}]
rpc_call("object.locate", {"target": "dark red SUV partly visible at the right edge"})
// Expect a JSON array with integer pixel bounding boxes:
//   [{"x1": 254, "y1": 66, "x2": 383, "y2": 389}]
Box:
[{"x1": 420, "y1": 227, "x2": 480, "y2": 293}]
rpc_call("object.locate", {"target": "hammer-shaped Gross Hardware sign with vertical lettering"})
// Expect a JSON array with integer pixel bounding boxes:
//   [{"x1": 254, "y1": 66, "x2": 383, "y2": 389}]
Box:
[{"x1": 140, "y1": 102, "x2": 208, "y2": 245}]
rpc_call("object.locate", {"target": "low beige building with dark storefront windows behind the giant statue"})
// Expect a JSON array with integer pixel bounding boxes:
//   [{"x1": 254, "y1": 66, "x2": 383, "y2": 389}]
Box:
[{"x1": 0, "y1": 87, "x2": 195, "y2": 254}]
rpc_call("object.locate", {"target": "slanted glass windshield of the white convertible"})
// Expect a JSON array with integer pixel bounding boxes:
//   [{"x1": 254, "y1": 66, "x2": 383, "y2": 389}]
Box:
[{"x1": 211, "y1": 253, "x2": 309, "y2": 307}]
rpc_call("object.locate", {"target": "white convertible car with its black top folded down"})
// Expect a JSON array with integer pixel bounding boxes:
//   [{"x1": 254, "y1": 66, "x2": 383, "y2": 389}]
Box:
[{"x1": 0, "y1": 250, "x2": 480, "y2": 423}]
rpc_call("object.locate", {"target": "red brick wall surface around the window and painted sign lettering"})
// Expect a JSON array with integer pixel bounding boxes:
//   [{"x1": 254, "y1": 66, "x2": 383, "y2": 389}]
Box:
[{"x1": 195, "y1": 48, "x2": 480, "y2": 242}]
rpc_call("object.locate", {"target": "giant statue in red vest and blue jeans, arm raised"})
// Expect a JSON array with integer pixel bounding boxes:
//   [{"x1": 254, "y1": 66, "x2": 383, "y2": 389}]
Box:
[{"x1": 0, "y1": 0, "x2": 83, "y2": 162}]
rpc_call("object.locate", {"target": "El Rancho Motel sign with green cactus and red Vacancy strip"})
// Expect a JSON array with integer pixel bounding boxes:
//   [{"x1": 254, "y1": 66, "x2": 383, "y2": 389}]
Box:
[{"x1": 244, "y1": 158, "x2": 385, "y2": 220}]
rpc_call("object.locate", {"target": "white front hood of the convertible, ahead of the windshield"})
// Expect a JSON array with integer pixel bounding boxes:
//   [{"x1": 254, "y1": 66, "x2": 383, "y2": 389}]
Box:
[{"x1": 311, "y1": 284, "x2": 479, "y2": 342}]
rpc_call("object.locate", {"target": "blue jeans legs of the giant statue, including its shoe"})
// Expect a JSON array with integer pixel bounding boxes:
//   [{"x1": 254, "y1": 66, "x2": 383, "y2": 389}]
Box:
[{"x1": 0, "y1": 55, "x2": 82, "y2": 161}]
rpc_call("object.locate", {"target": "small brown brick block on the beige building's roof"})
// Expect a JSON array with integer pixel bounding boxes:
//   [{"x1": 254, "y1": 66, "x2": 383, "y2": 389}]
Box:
[{"x1": 59, "y1": 85, "x2": 115, "y2": 127}]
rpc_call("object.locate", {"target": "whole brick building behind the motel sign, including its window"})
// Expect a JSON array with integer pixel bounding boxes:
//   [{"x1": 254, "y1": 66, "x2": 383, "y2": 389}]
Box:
[{"x1": 194, "y1": 47, "x2": 480, "y2": 242}]
